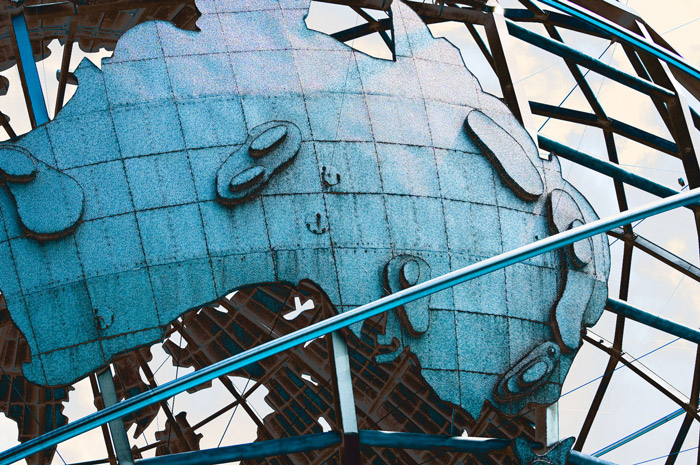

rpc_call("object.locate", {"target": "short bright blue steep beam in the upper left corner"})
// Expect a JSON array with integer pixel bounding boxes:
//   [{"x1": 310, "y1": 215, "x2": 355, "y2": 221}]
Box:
[{"x1": 12, "y1": 13, "x2": 49, "y2": 126}]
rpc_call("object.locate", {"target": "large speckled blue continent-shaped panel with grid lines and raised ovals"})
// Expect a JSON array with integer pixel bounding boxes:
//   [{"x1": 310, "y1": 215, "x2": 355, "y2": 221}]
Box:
[{"x1": 0, "y1": 0, "x2": 609, "y2": 417}]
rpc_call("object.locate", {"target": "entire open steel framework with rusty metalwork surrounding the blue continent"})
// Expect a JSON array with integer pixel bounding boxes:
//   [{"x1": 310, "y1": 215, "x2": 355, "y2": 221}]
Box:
[{"x1": 0, "y1": 0, "x2": 700, "y2": 465}]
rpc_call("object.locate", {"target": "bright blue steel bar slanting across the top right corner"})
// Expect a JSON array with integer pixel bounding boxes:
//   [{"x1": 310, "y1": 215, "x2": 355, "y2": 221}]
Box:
[{"x1": 539, "y1": 0, "x2": 700, "y2": 80}]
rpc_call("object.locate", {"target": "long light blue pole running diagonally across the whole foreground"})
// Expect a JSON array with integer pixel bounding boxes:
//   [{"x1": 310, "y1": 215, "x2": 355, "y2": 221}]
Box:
[{"x1": 0, "y1": 188, "x2": 700, "y2": 465}]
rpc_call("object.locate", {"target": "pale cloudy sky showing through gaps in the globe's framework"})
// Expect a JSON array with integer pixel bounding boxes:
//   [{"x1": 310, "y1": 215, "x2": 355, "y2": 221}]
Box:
[{"x1": 0, "y1": 0, "x2": 700, "y2": 465}]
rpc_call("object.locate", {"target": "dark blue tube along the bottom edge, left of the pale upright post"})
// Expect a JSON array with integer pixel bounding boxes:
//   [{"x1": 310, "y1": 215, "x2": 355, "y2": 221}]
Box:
[{"x1": 136, "y1": 431, "x2": 342, "y2": 465}]
